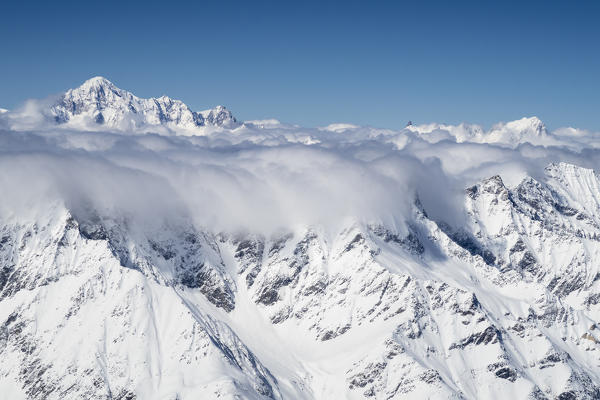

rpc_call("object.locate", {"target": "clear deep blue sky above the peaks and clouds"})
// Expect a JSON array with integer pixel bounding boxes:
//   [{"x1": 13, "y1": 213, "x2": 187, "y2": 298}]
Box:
[{"x1": 0, "y1": 1, "x2": 600, "y2": 130}]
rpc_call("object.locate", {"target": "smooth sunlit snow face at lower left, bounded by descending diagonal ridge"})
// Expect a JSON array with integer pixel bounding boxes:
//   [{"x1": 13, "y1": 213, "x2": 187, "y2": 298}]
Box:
[{"x1": 0, "y1": 205, "x2": 281, "y2": 398}]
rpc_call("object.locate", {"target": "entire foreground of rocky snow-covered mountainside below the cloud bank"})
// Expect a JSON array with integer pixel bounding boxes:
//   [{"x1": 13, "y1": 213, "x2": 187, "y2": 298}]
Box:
[{"x1": 0, "y1": 163, "x2": 600, "y2": 399}]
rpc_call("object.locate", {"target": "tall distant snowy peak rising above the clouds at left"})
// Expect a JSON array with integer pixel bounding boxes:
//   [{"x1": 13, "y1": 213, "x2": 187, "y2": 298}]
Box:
[{"x1": 50, "y1": 77, "x2": 237, "y2": 134}]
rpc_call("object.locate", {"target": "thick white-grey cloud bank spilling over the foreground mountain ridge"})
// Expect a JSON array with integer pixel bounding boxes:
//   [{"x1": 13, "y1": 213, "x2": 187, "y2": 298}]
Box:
[{"x1": 0, "y1": 106, "x2": 600, "y2": 233}]
